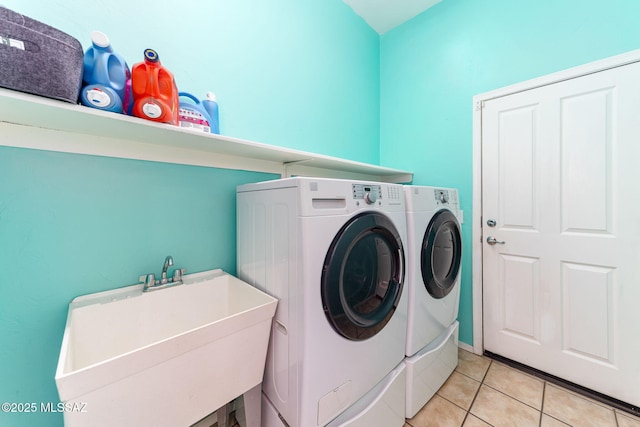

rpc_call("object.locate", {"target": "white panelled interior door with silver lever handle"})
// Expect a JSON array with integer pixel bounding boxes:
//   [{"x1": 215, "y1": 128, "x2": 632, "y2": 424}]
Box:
[{"x1": 481, "y1": 63, "x2": 640, "y2": 405}]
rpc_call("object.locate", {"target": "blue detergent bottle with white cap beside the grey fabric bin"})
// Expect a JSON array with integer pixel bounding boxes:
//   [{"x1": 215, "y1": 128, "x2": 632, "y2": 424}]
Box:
[{"x1": 80, "y1": 31, "x2": 133, "y2": 114}]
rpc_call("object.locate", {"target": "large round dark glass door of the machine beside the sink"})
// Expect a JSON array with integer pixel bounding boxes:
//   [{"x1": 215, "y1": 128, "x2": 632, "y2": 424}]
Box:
[{"x1": 322, "y1": 212, "x2": 405, "y2": 341}]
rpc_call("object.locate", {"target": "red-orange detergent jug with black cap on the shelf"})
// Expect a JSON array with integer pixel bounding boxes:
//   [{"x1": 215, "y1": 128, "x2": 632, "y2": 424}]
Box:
[{"x1": 131, "y1": 49, "x2": 179, "y2": 126}]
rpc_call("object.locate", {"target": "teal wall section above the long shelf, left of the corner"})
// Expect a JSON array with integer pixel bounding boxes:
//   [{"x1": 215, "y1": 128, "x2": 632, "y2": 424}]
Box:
[{"x1": 2, "y1": 0, "x2": 380, "y2": 164}]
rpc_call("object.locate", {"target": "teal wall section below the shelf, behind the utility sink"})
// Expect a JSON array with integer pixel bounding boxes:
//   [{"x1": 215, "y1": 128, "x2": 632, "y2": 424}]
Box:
[{"x1": 0, "y1": 147, "x2": 272, "y2": 427}]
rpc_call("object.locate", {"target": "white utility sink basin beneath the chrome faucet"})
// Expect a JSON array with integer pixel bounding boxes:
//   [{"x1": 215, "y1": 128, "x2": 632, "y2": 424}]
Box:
[{"x1": 56, "y1": 270, "x2": 277, "y2": 426}]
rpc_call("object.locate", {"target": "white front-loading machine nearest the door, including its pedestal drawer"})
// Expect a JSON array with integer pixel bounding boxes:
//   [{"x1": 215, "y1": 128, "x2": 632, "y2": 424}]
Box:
[{"x1": 404, "y1": 185, "x2": 462, "y2": 418}]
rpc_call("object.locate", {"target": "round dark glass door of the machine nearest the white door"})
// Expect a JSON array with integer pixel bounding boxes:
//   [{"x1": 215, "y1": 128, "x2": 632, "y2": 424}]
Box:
[{"x1": 420, "y1": 209, "x2": 462, "y2": 299}]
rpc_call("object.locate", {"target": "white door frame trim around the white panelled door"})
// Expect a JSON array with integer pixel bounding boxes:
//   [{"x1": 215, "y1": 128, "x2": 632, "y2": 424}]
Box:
[{"x1": 471, "y1": 49, "x2": 640, "y2": 354}]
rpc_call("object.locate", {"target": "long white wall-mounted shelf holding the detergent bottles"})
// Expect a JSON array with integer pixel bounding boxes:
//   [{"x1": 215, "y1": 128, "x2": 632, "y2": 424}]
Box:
[{"x1": 0, "y1": 88, "x2": 413, "y2": 183}]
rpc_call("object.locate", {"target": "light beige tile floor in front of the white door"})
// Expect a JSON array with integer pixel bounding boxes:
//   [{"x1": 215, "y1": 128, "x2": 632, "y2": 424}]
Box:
[{"x1": 405, "y1": 349, "x2": 640, "y2": 427}]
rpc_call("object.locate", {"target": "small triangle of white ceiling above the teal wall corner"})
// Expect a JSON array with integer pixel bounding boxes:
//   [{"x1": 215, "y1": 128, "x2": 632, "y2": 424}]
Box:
[{"x1": 342, "y1": 0, "x2": 440, "y2": 34}]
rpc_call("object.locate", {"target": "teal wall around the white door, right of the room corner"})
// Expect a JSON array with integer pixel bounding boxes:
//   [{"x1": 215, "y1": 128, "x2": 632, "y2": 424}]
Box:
[{"x1": 380, "y1": 0, "x2": 640, "y2": 344}]
